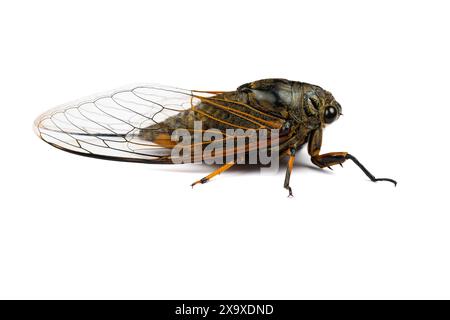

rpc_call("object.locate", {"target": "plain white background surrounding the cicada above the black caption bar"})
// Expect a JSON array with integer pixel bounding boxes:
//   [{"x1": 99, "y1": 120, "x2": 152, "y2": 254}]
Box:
[{"x1": 0, "y1": 0, "x2": 450, "y2": 299}]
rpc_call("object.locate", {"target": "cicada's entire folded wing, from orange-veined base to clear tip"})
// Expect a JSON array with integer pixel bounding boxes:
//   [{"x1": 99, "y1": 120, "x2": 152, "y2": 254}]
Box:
[{"x1": 35, "y1": 85, "x2": 289, "y2": 163}]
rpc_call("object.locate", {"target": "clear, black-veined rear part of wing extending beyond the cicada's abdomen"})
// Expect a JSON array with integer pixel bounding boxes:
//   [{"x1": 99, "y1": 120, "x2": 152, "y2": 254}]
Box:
[{"x1": 35, "y1": 85, "x2": 211, "y2": 163}]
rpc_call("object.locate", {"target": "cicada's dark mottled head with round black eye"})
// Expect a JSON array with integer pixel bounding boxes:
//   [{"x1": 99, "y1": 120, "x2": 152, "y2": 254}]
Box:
[{"x1": 302, "y1": 83, "x2": 342, "y2": 127}]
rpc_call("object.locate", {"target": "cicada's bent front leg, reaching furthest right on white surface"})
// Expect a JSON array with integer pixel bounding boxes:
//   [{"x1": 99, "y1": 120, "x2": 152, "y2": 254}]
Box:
[{"x1": 308, "y1": 129, "x2": 397, "y2": 185}]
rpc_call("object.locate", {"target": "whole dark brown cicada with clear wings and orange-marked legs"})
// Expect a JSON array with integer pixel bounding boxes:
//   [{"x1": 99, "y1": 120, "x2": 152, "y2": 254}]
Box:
[{"x1": 35, "y1": 79, "x2": 397, "y2": 196}]
